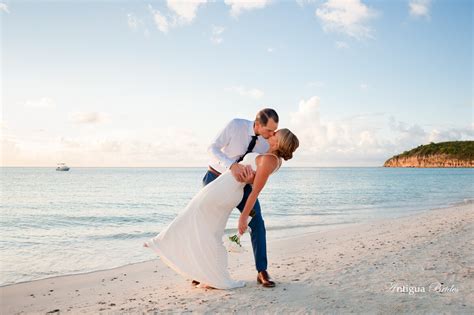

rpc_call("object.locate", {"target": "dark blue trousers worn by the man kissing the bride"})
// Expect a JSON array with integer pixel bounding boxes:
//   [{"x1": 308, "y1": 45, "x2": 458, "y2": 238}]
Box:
[{"x1": 202, "y1": 171, "x2": 267, "y2": 272}]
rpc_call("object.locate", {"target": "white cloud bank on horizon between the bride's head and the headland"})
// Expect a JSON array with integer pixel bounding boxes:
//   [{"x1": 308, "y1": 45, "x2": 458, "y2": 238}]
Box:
[{"x1": 288, "y1": 96, "x2": 474, "y2": 166}]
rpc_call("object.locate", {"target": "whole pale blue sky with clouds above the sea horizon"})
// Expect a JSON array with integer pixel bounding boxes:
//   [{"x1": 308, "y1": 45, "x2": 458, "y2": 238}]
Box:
[{"x1": 0, "y1": 0, "x2": 474, "y2": 167}]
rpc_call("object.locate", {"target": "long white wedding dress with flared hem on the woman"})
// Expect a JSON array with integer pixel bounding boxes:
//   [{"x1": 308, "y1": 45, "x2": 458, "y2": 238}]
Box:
[{"x1": 146, "y1": 152, "x2": 281, "y2": 289}]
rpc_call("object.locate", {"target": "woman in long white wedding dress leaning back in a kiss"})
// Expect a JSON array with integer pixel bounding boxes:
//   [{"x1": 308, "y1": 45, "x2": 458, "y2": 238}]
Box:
[{"x1": 143, "y1": 129, "x2": 299, "y2": 289}]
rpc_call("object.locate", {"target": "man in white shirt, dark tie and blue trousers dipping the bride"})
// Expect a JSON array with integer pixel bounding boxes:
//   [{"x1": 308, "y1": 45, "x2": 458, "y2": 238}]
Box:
[{"x1": 193, "y1": 108, "x2": 278, "y2": 287}]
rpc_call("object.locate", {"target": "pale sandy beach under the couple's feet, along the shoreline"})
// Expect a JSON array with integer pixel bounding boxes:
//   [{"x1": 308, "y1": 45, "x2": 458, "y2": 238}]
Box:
[{"x1": 0, "y1": 203, "x2": 474, "y2": 314}]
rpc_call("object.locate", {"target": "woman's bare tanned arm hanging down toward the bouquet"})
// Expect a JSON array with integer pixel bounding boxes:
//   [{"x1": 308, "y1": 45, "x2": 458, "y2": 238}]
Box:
[{"x1": 239, "y1": 155, "x2": 278, "y2": 234}]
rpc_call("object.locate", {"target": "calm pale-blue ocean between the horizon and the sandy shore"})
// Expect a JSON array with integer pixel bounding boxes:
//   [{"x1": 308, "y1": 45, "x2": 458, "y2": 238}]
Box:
[{"x1": 0, "y1": 167, "x2": 474, "y2": 285}]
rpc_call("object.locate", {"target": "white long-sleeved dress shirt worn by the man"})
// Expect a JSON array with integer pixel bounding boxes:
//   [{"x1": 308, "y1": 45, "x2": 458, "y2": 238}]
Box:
[{"x1": 207, "y1": 118, "x2": 270, "y2": 173}]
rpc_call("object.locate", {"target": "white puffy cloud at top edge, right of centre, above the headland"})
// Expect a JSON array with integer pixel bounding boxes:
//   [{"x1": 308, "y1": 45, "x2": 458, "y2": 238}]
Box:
[{"x1": 315, "y1": 0, "x2": 377, "y2": 39}]
